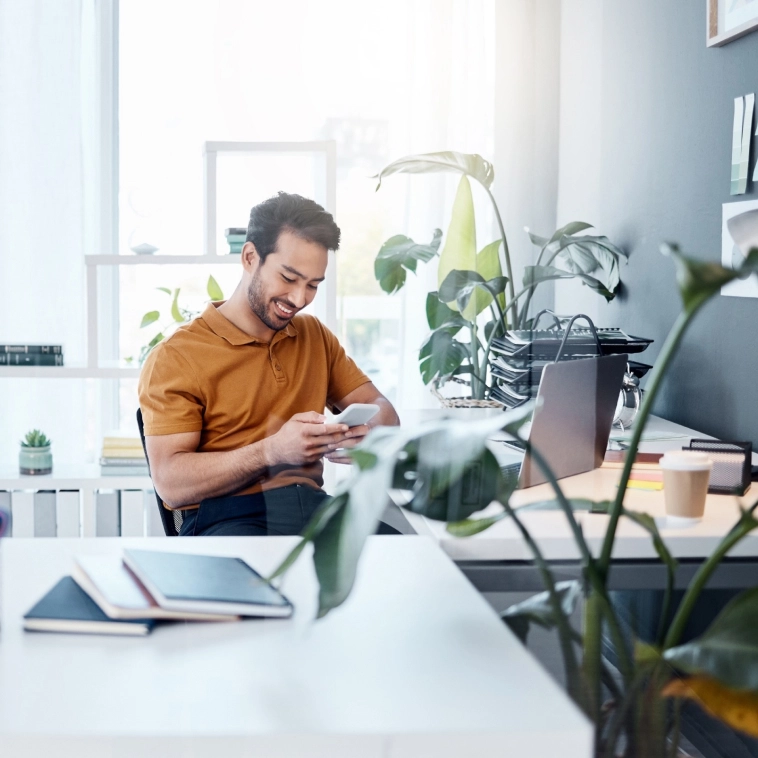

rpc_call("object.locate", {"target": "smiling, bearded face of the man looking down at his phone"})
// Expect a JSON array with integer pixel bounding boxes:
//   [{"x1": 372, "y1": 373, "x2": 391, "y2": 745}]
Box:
[{"x1": 247, "y1": 232, "x2": 329, "y2": 332}]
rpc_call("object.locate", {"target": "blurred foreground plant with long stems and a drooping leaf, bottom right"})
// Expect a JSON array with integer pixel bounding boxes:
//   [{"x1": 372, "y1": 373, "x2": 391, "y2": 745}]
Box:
[{"x1": 274, "y1": 246, "x2": 758, "y2": 758}]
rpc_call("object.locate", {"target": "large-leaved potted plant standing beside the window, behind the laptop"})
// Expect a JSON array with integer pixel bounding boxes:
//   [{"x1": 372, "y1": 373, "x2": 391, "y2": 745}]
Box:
[{"x1": 374, "y1": 152, "x2": 626, "y2": 400}]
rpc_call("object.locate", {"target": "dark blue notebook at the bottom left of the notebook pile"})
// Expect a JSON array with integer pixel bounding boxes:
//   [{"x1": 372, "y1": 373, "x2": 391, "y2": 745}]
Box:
[{"x1": 24, "y1": 576, "x2": 155, "y2": 637}]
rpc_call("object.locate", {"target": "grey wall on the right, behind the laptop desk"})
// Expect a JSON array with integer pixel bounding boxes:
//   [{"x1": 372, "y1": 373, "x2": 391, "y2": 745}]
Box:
[{"x1": 556, "y1": 0, "x2": 758, "y2": 445}]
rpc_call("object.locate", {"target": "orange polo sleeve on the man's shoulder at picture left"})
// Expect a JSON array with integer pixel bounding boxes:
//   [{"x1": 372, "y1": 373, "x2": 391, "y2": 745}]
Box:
[{"x1": 139, "y1": 343, "x2": 205, "y2": 436}]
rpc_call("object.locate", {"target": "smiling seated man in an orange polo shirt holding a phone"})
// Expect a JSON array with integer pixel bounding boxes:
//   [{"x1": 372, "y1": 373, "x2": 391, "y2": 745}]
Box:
[{"x1": 139, "y1": 192, "x2": 399, "y2": 535}]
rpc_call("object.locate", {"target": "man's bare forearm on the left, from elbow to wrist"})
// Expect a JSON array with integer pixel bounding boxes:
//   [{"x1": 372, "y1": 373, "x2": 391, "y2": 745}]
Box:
[{"x1": 153, "y1": 440, "x2": 269, "y2": 508}]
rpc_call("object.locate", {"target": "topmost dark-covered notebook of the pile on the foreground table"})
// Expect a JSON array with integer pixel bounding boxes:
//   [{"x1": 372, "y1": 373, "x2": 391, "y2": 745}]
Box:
[{"x1": 124, "y1": 550, "x2": 293, "y2": 618}]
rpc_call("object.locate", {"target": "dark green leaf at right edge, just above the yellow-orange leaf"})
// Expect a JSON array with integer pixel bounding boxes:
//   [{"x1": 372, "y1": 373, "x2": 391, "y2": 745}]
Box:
[{"x1": 664, "y1": 588, "x2": 758, "y2": 691}]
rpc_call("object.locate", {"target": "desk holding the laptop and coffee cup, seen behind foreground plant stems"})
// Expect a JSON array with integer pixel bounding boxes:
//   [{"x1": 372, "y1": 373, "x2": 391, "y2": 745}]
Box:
[{"x1": 404, "y1": 417, "x2": 758, "y2": 591}]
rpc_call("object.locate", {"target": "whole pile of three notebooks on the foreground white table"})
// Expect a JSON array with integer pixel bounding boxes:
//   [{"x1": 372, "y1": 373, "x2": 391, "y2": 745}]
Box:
[{"x1": 24, "y1": 550, "x2": 293, "y2": 636}]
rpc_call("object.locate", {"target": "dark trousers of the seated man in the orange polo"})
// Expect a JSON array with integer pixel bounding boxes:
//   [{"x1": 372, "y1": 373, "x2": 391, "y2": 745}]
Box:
[{"x1": 179, "y1": 484, "x2": 329, "y2": 537}]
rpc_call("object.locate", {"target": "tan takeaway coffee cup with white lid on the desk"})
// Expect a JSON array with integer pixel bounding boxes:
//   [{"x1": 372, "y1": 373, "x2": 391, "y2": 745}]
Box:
[{"x1": 660, "y1": 450, "x2": 713, "y2": 525}]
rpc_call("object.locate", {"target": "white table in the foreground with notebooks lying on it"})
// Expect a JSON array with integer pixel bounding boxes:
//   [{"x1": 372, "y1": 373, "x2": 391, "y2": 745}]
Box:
[{"x1": 0, "y1": 537, "x2": 592, "y2": 758}]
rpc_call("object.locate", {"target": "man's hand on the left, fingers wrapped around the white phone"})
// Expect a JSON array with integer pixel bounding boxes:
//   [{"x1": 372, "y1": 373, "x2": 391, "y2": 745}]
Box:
[{"x1": 265, "y1": 411, "x2": 352, "y2": 467}]
